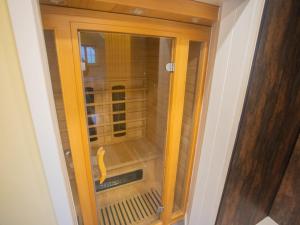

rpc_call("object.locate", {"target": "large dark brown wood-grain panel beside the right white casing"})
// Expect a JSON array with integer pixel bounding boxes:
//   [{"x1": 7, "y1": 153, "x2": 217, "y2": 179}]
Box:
[{"x1": 216, "y1": 0, "x2": 300, "y2": 225}]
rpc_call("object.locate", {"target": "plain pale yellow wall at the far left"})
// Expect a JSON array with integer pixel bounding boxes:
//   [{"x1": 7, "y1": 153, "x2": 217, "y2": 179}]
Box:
[{"x1": 0, "y1": 0, "x2": 57, "y2": 225}]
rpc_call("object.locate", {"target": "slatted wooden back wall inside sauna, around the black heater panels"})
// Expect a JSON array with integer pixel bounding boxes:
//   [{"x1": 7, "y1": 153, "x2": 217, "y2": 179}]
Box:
[{"x1": 81, "y1": 32, "x2": 147, "y2": 146}]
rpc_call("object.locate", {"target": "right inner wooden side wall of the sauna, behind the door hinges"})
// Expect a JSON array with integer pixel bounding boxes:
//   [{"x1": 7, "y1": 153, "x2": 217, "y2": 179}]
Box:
[{"x1": 146, "y1": 38, "x2": 172, "y2": 150}]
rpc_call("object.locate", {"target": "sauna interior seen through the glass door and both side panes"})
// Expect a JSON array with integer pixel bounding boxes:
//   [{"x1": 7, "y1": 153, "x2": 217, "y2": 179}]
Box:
[{"x1": 45, "y1": 31, "x2": 200, "y2": 222}]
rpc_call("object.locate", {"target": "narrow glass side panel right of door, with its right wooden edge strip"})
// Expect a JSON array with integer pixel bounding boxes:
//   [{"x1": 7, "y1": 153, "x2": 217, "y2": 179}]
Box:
[{"x1": 173, "y1": 41, "x2": 207, "y2": 216}]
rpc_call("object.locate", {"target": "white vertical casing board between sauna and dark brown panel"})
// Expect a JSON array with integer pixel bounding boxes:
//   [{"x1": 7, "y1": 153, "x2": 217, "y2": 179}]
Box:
[{"x1": 186, "y1": 0, "x2": 264, "y2": 225}]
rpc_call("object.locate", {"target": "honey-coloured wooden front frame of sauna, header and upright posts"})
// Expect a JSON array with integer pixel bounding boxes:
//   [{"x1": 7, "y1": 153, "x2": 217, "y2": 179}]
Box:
[{"x1": 42, "y1": 7, "x2": 210, "y2": 225}]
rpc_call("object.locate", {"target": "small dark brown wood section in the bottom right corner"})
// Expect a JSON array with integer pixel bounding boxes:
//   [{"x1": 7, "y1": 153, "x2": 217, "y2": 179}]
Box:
[{"x1": 270, "y1": 135, "x2": 300, "y2": 225}]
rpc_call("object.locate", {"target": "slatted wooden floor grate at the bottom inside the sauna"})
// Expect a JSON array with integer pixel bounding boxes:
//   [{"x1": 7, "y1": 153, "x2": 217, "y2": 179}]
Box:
[{"x1": 99, "y1": 189, "x2": 162, "y2": 225}]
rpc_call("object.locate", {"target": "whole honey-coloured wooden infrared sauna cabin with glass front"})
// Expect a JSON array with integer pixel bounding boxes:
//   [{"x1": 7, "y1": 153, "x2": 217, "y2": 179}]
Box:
[{"x1": 41, "y1": 1, "x2": 218, "y2": 225}]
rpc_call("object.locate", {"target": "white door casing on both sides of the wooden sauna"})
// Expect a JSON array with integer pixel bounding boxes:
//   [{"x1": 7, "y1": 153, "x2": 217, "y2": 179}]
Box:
[{"x1": 7, "y1": 0, "x2": 264, "y2": 225}]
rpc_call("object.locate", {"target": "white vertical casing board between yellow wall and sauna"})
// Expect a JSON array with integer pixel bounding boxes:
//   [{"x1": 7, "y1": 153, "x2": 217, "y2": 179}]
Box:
[{"x1": 6, "y1": 0, "x2": 77, "y2": 225}]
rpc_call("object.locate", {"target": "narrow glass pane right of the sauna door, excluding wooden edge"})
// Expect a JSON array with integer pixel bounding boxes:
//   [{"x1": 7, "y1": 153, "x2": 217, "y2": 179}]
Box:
[{"x1": 173, "y1": 41, "x2": 201, "y2": 212}]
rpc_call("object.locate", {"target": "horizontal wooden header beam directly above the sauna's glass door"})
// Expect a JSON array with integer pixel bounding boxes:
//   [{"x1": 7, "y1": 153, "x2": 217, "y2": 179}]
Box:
[{"x1": 41, "y1": 6, "x2": 210, "y2": 42}]
